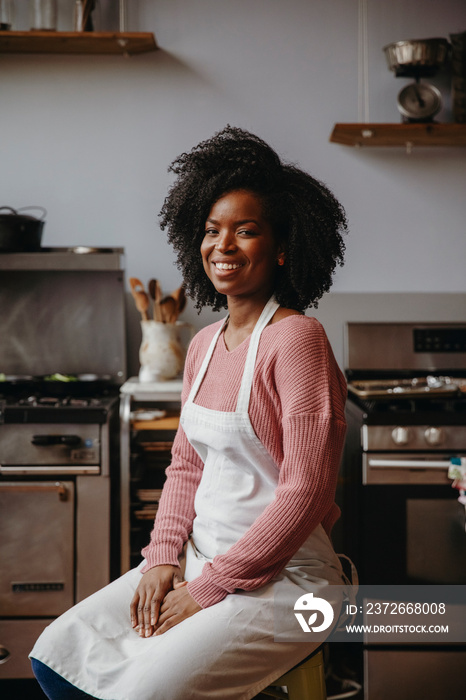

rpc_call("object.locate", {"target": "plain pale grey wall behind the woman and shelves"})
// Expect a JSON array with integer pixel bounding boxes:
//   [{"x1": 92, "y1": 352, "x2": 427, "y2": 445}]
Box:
[{"x1": 0, "y1": 0, "x2": 466, "y2": 370}]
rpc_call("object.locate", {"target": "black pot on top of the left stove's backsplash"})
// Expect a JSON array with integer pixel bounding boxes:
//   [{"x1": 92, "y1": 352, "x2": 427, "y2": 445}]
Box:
[{"x1": 0, "y1": 207, "x2": 47, "y2": 253}]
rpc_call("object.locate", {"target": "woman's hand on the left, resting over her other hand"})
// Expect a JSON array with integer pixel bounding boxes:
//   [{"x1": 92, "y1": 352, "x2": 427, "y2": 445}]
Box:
[{"x1": 130, "y1": 565, "x2": 186, "y2": 637}]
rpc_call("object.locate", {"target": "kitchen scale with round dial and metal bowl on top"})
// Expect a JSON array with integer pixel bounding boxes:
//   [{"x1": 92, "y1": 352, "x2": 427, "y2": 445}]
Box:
[{"x1": 383, "y1": 38, "x2": 450, "y2": 123}]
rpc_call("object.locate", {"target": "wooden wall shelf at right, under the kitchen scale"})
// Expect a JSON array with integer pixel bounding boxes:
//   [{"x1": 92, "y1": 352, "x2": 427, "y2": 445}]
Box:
[{"x1": 330, "y1": 123, "x2": 466, "y2": 150}]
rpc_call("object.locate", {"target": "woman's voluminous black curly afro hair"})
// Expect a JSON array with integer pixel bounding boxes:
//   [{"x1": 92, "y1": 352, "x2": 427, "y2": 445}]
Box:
[{"x1": 160, "y1": 126, "x2": 347, "y2": 311}]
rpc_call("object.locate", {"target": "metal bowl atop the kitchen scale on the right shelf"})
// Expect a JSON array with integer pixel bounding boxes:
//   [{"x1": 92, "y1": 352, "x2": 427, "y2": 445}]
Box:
[{"x1": 383, "y1": 38, "x2": 450, "y2": 76}]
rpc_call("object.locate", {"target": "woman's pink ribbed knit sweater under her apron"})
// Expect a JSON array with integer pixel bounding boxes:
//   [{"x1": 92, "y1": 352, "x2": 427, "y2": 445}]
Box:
[{"x1": 142, "y1": 315, "x2": 346, "y2": 608}]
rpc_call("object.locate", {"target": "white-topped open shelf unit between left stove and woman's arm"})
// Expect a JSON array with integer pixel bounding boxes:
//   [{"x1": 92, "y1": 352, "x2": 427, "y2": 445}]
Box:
[{"x1": 120, "y1": 377, "x2": 182, "y2": 573}]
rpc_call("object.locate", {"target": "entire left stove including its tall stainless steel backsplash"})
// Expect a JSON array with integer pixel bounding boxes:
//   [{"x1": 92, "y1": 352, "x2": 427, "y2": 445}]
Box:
[{"x1": 0, "y1": 249, "x2": 126, "y2": 679}]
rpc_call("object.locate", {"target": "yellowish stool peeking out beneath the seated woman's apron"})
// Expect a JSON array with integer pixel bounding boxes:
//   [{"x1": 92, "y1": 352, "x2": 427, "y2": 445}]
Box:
[{"x1": 261, "y1": 647, "x2": 327, "y2": 700}]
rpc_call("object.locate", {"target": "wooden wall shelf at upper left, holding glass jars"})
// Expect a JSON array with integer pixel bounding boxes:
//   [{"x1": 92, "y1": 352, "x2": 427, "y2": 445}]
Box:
[{"x1": 0, "y1": 30, "x2": 158, "y2": 56}]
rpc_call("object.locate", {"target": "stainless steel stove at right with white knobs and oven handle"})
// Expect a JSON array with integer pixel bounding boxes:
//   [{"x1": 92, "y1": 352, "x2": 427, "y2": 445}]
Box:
[{"x1": 338, "y1": 323, "x2": 466, "y2": 700}]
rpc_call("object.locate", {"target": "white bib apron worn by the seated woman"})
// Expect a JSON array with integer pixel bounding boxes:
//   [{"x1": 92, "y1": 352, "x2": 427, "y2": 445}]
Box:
[{"x1": 31, "y1": 300, "x2": 343, "y2": 700}]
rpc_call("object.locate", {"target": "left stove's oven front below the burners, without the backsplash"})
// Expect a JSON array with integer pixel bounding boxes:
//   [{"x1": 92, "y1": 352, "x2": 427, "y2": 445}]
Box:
[{"x1": 0, "y1": 398, "x2": 117, "y2": 678}]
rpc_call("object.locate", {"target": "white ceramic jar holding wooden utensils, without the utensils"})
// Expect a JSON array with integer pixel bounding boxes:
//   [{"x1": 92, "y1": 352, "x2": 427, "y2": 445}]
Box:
[{"x1": 139, "y1": 321, "x2": 194, "y2": 382}]
